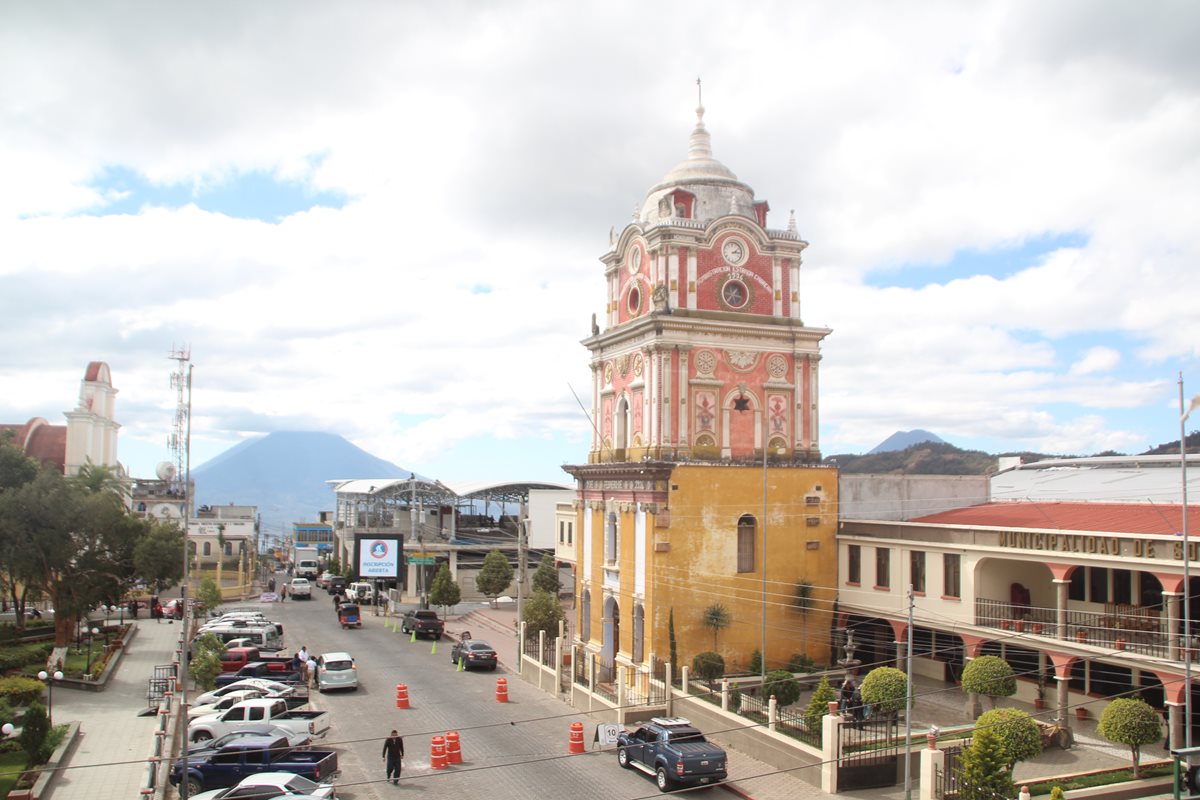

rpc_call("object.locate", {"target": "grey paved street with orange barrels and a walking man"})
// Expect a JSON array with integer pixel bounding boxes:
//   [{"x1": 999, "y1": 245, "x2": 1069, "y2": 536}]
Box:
[{"x1": 264, "y1": 591, "x2": 728, "y2": 800}]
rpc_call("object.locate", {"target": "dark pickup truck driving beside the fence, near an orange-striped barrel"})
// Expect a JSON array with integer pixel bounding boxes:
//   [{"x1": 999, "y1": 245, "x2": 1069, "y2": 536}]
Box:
[{"x1": 617, "y1": 717, "x2": 727, "y2": 792}]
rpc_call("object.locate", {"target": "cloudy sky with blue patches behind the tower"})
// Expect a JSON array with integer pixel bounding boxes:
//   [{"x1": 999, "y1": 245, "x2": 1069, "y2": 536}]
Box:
[{"x1": 0, "y1": 0, "x2": 1200, "y2": 480}]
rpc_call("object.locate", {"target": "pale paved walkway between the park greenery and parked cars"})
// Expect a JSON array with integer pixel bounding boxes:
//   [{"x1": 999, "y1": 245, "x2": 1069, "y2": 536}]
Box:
[{"x1": 43, "y1": 620, "x2": 181, "y2": 800}]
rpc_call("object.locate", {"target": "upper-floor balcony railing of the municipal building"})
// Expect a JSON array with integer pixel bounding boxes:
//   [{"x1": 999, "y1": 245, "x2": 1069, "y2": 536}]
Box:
[{"x1": 976, "y1": 597, "x2": 1169, "y2": 658}]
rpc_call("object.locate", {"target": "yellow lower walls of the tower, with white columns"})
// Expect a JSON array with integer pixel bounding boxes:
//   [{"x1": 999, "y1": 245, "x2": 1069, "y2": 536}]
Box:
[{"x1": 576, "y1": 464, "x2": 838, "y2": 672}]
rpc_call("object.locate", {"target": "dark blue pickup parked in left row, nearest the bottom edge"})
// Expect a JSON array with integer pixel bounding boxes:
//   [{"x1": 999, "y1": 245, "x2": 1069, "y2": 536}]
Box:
[{"x1": 170, "y1": 736, "x2": 338, "y2": 796}]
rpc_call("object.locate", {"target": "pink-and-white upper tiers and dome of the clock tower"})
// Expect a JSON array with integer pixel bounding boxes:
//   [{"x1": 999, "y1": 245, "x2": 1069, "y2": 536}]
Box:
[{"x1": 583, "y1": 106, "x2": 830, "y2": 464}]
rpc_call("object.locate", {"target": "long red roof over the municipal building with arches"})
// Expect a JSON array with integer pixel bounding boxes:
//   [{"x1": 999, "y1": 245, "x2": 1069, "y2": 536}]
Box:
[{"x1": 912, "y1": 503, "x2": 1200, "y2": 536}]
